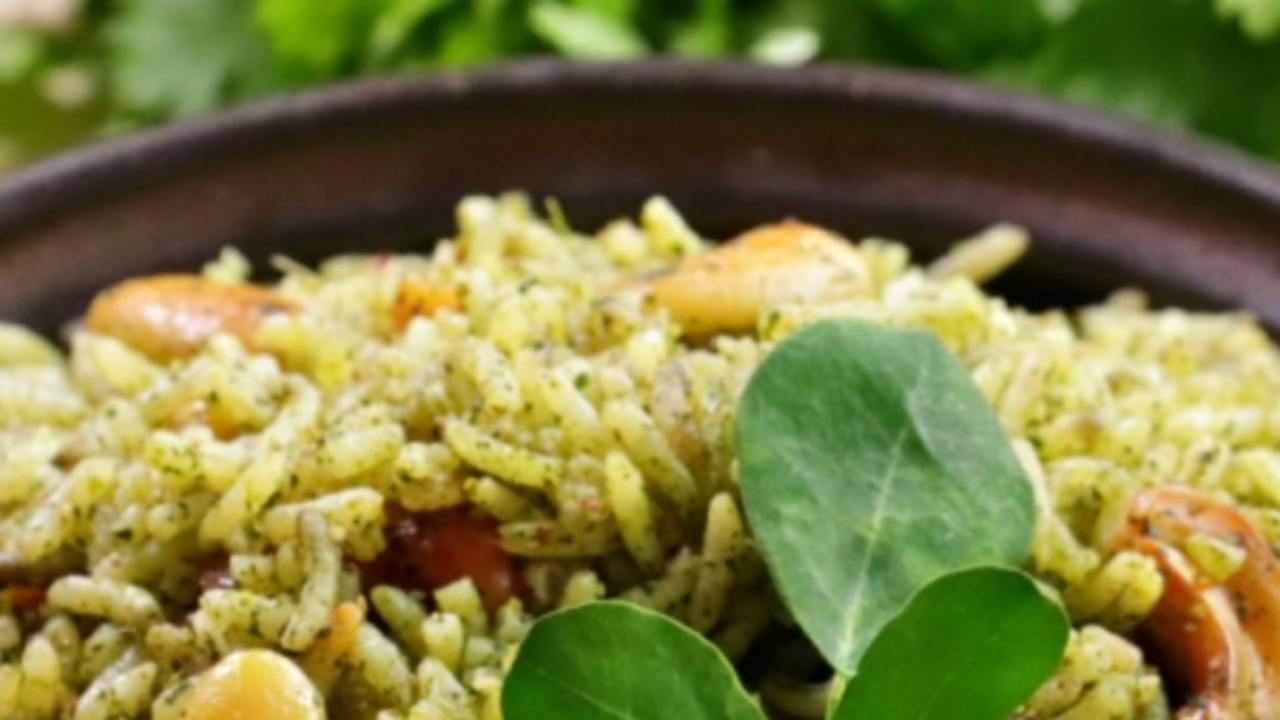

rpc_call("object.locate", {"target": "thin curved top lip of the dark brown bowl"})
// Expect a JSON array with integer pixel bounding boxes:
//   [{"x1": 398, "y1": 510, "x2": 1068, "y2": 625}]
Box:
[{"x1": 0, "y1": 59, "x2": 1280, "y2": 238}]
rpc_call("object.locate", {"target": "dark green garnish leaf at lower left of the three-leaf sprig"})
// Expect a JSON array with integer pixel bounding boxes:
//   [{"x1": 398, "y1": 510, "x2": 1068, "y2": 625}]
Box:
[{"x1": 502, "y1": 602, "x2": 764, "y2": 720}]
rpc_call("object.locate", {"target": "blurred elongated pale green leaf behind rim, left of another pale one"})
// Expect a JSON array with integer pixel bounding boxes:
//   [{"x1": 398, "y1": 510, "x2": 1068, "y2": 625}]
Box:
[{"x1": 529, "y1": 3, "x2": 649, "y2": 60}]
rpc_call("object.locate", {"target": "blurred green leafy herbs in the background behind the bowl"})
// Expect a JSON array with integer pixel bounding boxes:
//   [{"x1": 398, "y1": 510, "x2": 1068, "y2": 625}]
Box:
[{"x1": 0, "y1": 0, "x2": 1280, "y2": 168}]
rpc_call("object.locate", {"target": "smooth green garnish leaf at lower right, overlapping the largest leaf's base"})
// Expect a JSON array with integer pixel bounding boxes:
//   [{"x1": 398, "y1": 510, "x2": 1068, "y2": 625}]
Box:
[{"x1": 832, "y1": 568, "x2": 1070, "y2": 720}]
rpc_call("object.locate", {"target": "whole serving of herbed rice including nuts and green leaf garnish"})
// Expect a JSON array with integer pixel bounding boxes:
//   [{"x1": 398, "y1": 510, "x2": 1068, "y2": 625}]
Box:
[{"x1": 0, "y1": 193, "x2": 1280, "y2": 720}]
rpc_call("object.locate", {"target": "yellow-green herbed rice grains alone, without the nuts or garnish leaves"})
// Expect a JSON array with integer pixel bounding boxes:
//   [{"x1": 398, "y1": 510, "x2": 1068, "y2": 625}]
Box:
[{"x1": 0, "y1": 196, "x2": 1280, "y2": 720}]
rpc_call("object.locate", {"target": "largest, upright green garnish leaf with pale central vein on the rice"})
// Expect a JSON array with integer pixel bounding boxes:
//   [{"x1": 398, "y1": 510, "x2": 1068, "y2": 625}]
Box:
[{"x1": 736, "y1": 320, "x2": 1034, "y2": 673}]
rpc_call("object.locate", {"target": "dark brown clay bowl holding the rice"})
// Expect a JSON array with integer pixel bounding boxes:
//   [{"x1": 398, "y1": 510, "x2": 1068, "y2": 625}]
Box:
[{"x1": 0, "y1": 63, "x2": 1280, "y2": 331}]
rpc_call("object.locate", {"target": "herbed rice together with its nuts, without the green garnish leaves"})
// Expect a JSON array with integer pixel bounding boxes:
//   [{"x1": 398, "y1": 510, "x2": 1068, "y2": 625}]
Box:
[{"x1": 0, "y1": 195, "x2": 1280, "y2": 720}]
